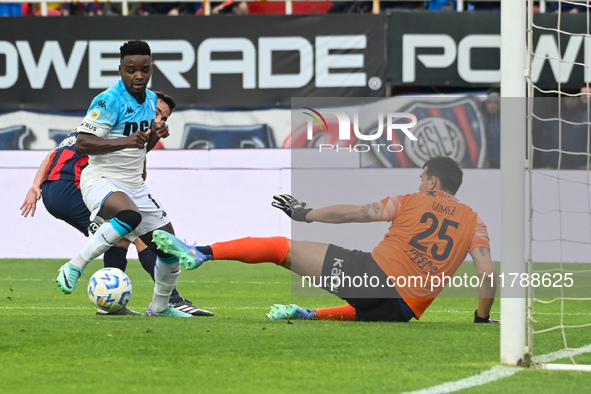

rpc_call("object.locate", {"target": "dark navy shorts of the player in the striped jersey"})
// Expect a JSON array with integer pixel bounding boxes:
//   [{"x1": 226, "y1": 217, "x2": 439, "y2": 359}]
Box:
[{"x1": 41, "y1": 181, "x2": 90, "y2": 237}]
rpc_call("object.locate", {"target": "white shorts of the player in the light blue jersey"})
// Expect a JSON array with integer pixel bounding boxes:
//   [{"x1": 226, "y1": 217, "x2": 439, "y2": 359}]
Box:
[{"x1": 82, "y1": 178, "x2": 170, "y2": 242}]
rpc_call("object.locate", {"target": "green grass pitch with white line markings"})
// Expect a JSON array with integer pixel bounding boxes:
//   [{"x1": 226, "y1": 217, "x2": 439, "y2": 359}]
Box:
[{"x1": 0, "y1": 260, "x2": 591, "y2": 394}]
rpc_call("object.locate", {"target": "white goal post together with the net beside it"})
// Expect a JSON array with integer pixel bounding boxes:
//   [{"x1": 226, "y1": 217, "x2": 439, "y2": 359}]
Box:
[{"x1": 499, "y1": 0, "x2": 591, "y2": 372}]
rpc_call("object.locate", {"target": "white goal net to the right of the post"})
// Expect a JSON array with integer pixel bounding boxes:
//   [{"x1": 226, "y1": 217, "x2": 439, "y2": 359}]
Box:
[{"x1": 528, "y1": 0, "x2": 591, "y2": 371}]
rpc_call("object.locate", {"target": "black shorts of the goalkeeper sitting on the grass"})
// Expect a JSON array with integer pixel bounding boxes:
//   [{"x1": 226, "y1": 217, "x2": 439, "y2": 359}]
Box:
[{"x1": 322, "y1": 244, "x2": 414, "y2": 322}]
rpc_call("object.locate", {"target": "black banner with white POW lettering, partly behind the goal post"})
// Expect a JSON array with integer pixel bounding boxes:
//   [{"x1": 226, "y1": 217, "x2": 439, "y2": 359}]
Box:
[{"x1": 386, "y1": 12, "x2": 591, "y2": 89}]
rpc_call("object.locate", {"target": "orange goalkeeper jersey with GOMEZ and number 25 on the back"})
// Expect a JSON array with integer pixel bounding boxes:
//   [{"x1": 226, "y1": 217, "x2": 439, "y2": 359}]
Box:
[{"x1": 371, "y1": 190, "x2": 490, "y2": 319}]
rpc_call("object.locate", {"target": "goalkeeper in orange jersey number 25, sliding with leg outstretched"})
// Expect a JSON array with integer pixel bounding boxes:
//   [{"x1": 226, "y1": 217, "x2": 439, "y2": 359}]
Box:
[{"x1": 154, "y1": 156, "x2": 497, "y2": 323}]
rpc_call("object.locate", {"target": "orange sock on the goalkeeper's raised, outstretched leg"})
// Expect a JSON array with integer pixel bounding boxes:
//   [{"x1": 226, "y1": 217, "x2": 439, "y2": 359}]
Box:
[{"x1": 211, "y1": 237, "x2": 289, "y2": 265}]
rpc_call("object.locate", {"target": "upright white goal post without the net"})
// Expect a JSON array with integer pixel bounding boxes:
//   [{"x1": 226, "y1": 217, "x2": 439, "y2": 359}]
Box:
[{"x1": 500, "y1": 0, "x2": 527, "y2": 365}]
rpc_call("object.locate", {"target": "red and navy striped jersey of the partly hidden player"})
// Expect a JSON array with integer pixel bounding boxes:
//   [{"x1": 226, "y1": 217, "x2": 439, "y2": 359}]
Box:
[{"x1": 43, "y1": 131, "x2": 88, "y2": 188}]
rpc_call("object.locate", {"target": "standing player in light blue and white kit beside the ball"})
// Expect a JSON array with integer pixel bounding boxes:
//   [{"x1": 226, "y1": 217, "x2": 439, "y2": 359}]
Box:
[{"x1": 56, "y1": 41, "x2": 201, "y2": 317}]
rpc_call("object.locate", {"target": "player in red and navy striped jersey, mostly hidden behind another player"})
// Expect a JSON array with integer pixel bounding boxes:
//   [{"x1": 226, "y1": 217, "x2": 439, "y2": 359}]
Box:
[{"x1": 21, "y1": 92, "x2": 213, "y2": 316}]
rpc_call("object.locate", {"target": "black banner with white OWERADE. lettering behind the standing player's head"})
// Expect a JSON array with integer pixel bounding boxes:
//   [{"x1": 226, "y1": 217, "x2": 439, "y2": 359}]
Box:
[{"x1": 0, "y1": 15, "x2": 386, "y2": 111}]
